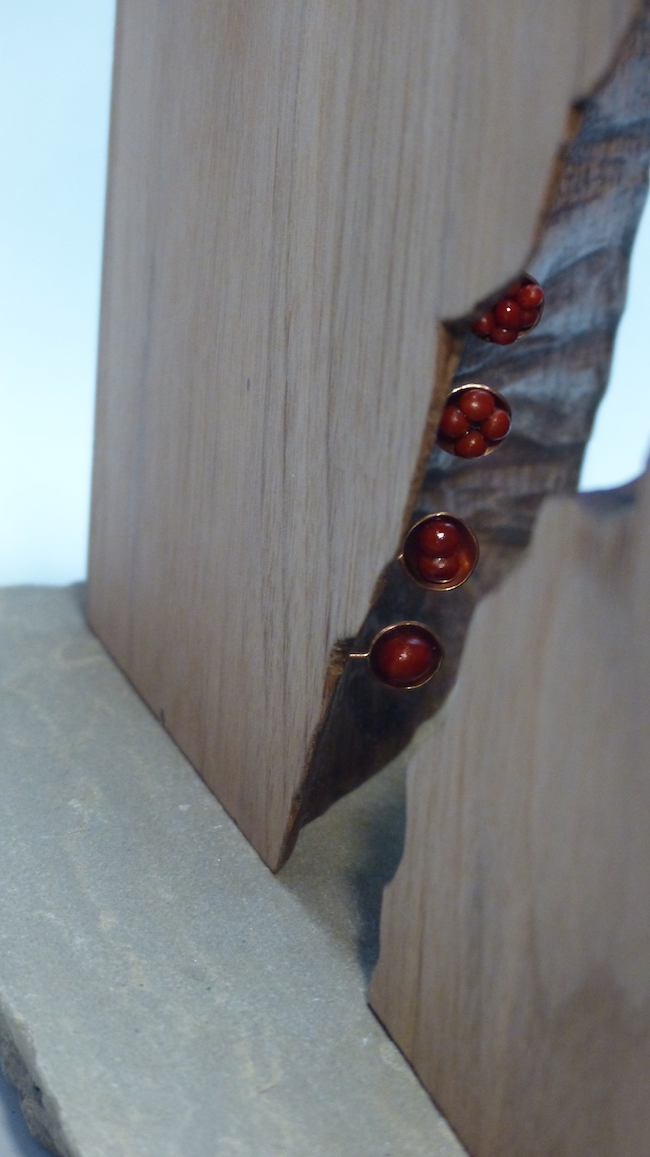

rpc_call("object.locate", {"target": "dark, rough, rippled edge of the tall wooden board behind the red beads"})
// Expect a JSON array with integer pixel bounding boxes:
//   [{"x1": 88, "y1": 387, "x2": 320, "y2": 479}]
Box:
[{"x1": 301, "y1": 5, "x2": 650, "y2": 823}]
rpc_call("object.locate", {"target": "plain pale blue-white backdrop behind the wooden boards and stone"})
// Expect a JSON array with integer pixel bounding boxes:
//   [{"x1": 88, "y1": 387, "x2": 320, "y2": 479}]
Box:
[{"x1": 0, "y1": 0, "x2": 650, "y2": 1157}]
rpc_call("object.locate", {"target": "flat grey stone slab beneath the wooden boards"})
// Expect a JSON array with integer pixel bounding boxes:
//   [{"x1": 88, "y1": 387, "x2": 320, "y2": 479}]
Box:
[{"x1": 0, "y1": 588, "x2": 463, "y2": 1157}]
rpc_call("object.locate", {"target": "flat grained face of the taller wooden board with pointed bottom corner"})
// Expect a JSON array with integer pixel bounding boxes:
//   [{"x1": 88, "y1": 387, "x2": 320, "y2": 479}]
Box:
[{"x1": 88, "y1": 0, "x2": 635, "y2": 868}]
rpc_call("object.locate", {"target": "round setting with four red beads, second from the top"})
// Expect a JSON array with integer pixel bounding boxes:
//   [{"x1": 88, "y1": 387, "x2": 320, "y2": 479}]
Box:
[{"x1": 438, "y1": 385, "x2": 510, "y2": 458}]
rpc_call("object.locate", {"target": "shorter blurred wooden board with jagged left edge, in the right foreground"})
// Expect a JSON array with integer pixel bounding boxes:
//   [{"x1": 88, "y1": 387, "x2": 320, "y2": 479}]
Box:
[{"x1": 371, "y1": 476, "x2": 650, "y2": 1157}]
